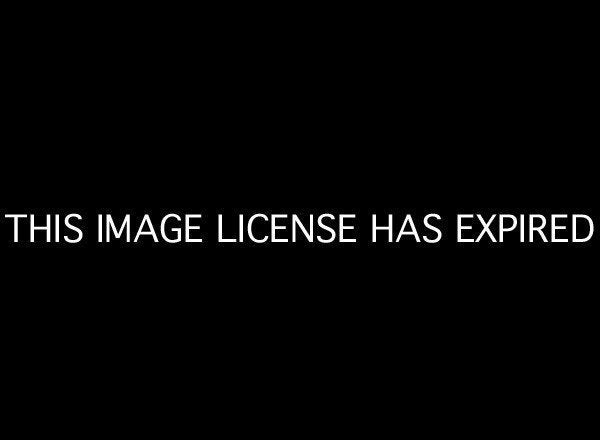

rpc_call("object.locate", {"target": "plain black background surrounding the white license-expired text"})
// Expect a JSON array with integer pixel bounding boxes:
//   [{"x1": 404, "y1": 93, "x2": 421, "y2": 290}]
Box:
[{"x1": 1, "y1": 5, "x2": 598, "y2": 433}]
